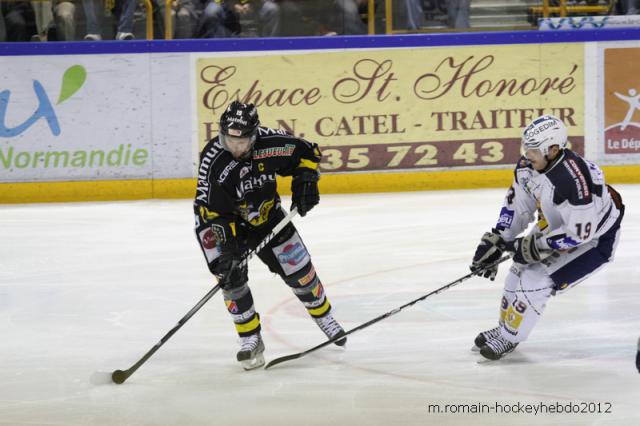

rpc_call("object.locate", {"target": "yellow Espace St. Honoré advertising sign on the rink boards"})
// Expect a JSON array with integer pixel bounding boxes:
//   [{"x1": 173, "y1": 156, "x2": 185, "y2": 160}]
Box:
[{"x1": 196, "y1": 44, "x2": 584, "y2": 171}]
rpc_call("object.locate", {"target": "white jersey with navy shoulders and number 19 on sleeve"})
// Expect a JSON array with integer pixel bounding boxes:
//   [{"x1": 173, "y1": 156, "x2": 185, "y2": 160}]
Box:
[{"x1": 496, "y1": 149, "x2": 620, "y2": 251}]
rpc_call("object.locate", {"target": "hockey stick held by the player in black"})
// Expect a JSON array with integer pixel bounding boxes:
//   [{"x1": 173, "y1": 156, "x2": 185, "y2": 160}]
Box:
[{"x1": 111, "y1": 208, "x2": 298, "y2": 384}]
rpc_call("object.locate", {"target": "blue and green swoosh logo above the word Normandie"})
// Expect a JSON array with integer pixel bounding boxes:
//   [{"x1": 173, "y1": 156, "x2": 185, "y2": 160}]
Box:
[{"x1": 0, "y1": 65, "x2": 87, "y2": 138}]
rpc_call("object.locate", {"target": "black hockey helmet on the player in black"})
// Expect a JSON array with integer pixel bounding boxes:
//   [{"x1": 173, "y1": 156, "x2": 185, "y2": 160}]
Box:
[{"x1": 218, "y1": 101, "x2": 260, "y2": 160}]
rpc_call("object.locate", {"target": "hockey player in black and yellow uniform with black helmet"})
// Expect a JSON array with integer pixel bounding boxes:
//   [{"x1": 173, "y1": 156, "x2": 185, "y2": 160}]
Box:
[{"x1": 194, "y1": 101, "x2": 347, "y2": 370}]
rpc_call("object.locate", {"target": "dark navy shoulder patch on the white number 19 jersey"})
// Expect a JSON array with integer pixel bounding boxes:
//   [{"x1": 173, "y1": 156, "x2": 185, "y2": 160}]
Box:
[{"x1": 545, "y1": 150, "x2": 594, "y2": 206}]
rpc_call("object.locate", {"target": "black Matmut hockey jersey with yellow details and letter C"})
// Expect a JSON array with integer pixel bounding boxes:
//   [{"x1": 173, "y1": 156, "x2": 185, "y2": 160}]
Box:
[{"x1": 194, "y1": 127, "x2": 321, "y2": 233}]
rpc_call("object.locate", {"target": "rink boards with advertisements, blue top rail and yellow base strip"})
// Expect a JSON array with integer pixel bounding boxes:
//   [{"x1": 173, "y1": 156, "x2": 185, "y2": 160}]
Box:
[{"x1": 0, "y1": 29, "x2": 640, "y2": 203}]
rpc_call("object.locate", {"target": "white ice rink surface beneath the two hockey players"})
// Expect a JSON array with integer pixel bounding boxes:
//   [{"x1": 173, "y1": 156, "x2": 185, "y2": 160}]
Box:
[{"x1": 0, "y1": 185, "x2": 640, "y2": 426}]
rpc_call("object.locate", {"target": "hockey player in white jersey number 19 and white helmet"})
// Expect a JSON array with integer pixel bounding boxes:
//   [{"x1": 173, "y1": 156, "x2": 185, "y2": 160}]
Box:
[{"x1": 471, "y1": 115, "x2": 624, "y2": 360}]
